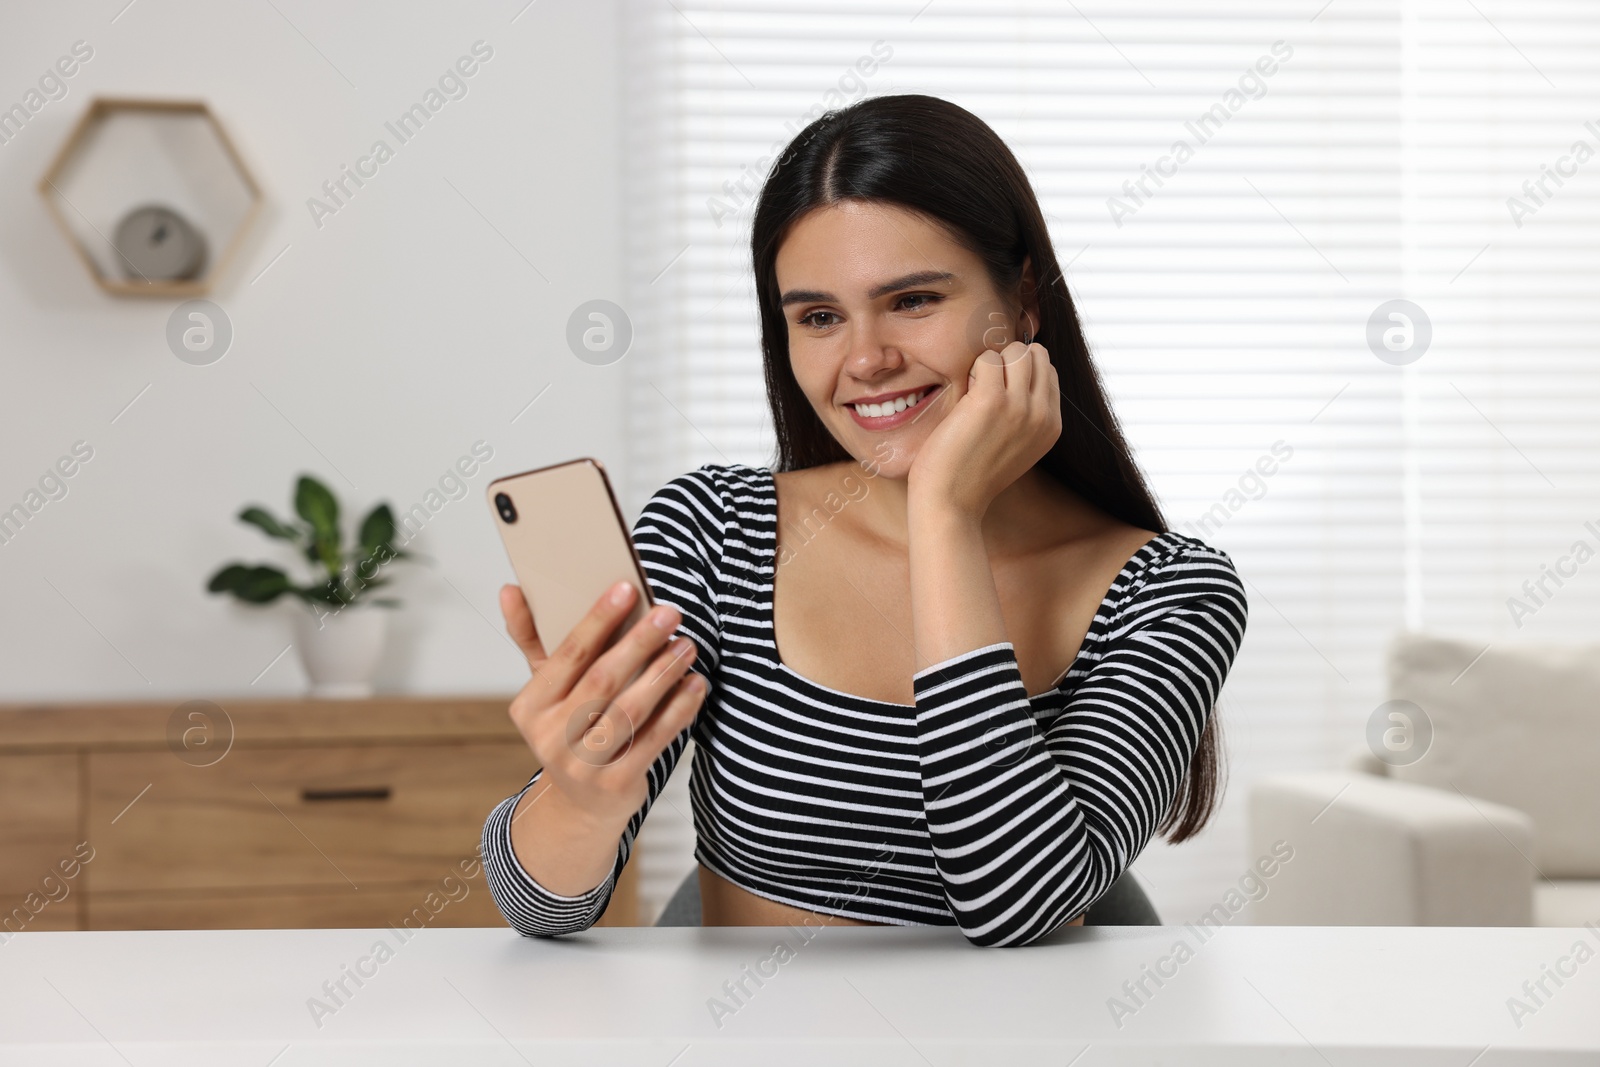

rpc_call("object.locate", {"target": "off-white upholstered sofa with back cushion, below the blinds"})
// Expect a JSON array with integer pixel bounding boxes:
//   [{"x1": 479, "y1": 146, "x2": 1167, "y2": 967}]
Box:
[{"x1": 1250, "y1": 633, "x2": 1600, "y2": 926}]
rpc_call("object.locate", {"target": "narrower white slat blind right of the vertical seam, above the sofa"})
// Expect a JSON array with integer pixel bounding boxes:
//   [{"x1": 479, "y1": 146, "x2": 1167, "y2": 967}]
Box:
[{"x1": 1408, "y1": 0, "x2": 1600, "y2": 645}]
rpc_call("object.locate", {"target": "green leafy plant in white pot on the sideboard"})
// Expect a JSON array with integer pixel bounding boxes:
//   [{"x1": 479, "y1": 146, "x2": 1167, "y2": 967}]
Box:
[{"x1": 206, "y1": 475, "x2": 411, "y2": 696}]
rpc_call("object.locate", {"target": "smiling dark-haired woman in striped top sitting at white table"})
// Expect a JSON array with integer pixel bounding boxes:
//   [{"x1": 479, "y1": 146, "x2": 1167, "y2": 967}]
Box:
[{"x1": 483, "y1": 89, "x2": 1245, "y2": 945}]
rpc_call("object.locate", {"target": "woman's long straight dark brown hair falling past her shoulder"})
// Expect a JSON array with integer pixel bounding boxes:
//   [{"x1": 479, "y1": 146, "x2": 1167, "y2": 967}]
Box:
[{"x1": 750, "y1": 94, "x2": 1221, "y2": 845}]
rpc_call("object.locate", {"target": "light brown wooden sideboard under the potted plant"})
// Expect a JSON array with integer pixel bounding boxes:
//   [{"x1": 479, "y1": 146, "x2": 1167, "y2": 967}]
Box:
[{"x1": 0, "y1": 696, "x2": 638, "y2": 941}]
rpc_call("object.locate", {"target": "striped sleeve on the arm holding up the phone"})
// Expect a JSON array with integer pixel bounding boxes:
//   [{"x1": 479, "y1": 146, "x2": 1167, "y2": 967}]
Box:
[{"x1": 483, "y1": 477, "x2": 728, "y2": 937}]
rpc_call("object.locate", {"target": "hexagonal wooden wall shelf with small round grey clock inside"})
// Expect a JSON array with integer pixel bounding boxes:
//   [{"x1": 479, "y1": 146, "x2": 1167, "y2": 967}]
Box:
[{"x1": 38, "y1": 98, "x2": 261, "y2": 298}]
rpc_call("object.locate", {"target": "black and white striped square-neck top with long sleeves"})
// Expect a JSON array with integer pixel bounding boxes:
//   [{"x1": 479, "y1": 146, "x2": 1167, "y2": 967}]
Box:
[{"x1": 483, "y1": 464, "x2": 1246, "y2": 945}]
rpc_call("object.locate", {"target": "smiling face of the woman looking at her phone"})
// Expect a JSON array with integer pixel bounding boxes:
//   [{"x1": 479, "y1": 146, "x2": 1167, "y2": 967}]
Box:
[{"x1": 774, "y1": 200, "x2": 1038, "y2": 478}]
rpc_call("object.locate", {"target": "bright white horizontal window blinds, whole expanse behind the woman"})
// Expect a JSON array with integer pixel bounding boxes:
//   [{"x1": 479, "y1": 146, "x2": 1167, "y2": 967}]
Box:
[{"x1": 624, "y1": 0, "x2": 1600, "y2": 921}]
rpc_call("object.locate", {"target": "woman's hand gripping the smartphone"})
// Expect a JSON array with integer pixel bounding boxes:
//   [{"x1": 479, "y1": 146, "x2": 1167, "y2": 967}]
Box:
[{"x1": 501, "y1": 582, "x2": 707, "y2": 832}]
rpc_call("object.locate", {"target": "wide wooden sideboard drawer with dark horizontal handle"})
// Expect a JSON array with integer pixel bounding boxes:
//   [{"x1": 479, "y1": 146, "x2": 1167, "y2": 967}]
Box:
[{"x1": 88, "y1": 739, "x2": 534, "y2": 893}]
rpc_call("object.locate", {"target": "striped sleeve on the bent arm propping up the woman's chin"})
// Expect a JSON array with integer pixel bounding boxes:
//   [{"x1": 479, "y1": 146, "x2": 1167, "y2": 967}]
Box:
[{"x1": 912, "y1": 542, "x2": 1246, "y2": 945}]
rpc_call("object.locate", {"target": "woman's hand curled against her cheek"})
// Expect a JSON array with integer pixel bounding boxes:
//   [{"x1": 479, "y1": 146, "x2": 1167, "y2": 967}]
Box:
[{"x1": 906, "y1": 341, "x2": 1061, "y2": 522}]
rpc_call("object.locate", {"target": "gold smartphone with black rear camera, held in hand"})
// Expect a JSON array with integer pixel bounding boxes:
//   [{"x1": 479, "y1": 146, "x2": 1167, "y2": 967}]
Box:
[{"x1": 485, "y1": 456, "x2": 656, "y2": 654}]
